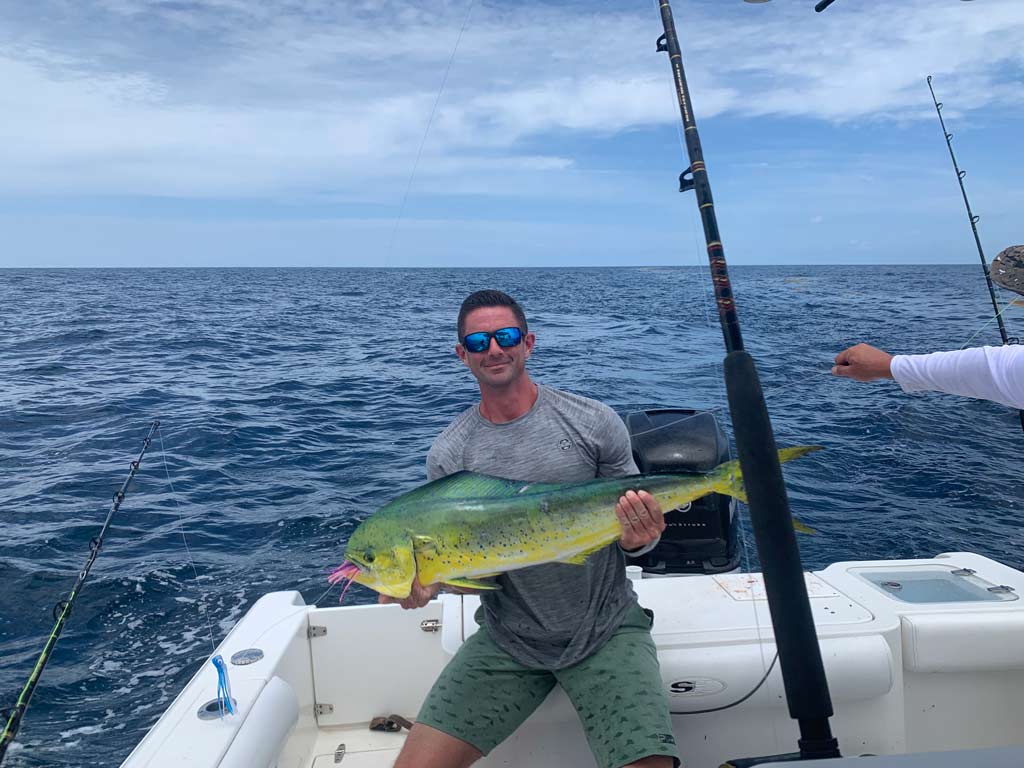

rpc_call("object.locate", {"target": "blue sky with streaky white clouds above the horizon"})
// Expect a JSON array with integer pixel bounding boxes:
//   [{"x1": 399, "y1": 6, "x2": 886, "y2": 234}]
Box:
[{"x1": 0, "y1": 0, "x2": 1024, "y2": 267}]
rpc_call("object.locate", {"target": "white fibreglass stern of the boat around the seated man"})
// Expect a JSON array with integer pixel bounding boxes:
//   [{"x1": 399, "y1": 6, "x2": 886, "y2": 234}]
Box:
[{"x1": 117, "y1": 553, "x2": 1024, "y2": 768}]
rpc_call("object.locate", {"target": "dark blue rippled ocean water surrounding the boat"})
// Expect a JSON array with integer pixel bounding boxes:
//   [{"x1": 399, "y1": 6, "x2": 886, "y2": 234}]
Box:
[{"x1": 0, "y1": 265, "x2": 1024, "y2": 767}]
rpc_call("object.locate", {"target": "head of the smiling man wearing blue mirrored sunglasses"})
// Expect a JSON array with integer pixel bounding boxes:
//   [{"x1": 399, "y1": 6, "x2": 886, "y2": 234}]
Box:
[{"x1": 455, "y1": 291, "x2": 535, "y2": 388}]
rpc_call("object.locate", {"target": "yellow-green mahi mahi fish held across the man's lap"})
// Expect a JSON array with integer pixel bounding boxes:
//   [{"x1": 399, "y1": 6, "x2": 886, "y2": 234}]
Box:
[{"x1": 330, "y1": 445, "x2": 820, "y2": 598}]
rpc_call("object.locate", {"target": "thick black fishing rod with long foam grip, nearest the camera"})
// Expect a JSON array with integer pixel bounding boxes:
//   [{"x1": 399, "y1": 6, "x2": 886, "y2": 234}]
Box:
[{"x1": 657, "y1": 0, "x2": 840, "y2": 760}]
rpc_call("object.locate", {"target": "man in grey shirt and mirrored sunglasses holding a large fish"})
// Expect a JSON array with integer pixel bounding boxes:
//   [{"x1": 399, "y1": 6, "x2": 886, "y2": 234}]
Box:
[{"x1": 381, "y1": 291, "x2": 678, "y2": 768}]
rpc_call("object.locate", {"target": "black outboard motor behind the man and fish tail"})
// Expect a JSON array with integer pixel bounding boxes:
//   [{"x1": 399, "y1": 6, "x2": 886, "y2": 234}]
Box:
[{"x1": 624, "y1": 409, "x2": 740, "y2": 575}]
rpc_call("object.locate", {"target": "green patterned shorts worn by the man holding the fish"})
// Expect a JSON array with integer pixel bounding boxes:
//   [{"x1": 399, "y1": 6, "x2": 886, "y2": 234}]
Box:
[{"x1": 417, "y1": 605, "x2": 679, "y2": 768}]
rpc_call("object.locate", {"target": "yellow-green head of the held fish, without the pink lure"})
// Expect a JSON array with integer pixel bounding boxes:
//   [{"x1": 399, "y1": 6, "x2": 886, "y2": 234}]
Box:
[{"x1": 337, "y1": 517, "x2": 416, "y2": 598}]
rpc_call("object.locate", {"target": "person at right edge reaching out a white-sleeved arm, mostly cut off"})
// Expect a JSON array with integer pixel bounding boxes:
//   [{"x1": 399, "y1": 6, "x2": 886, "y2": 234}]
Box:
[{"x1": 833, "y1": 246, "x2": 1024, "y2": 409}]
